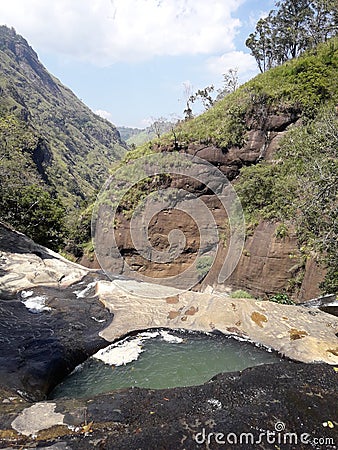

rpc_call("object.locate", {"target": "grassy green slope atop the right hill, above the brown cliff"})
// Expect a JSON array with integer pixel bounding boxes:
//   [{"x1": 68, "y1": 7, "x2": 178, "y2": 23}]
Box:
[{"x1": 143, "y1": 37, "x2": 338, "y2": 154}]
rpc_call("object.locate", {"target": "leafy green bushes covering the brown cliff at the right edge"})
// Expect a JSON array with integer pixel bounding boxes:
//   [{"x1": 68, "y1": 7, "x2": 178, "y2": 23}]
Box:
[{"x1": 236, "y1": 106, "x2": 338, "y2": 293}]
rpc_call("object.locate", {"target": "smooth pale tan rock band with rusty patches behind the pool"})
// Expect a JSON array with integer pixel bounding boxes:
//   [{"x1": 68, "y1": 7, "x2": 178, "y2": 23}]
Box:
[{"x1": 97, "y1": 280, "x2": 338, "y2": 364}]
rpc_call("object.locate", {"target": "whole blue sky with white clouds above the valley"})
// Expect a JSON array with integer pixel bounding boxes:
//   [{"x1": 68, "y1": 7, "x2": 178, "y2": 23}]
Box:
[{"x1": 0, "y1": 0, "x2": 274, "y2": 128}]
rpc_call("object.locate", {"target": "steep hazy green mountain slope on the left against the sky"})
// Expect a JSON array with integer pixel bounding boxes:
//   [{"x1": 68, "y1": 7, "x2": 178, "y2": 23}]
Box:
[{"x1": 0, "y1": 26, "x2": 126, "y2": 208}]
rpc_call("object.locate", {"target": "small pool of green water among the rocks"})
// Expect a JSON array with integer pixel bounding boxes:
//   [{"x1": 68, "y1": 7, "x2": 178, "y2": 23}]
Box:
[{"x1": 50, "y1": 332, "x2": 280, "y2": 398}]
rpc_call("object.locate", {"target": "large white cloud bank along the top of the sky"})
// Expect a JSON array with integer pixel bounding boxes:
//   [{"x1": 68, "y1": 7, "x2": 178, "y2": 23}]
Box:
[{"x1": 1, "y1": 0, "x2": 244, "y2": 65}]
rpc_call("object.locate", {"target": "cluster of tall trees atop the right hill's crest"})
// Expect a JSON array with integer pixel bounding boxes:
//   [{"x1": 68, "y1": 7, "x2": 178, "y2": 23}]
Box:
[{"x1": 245, "y1": 0, "x2": 338, "y2": 72}]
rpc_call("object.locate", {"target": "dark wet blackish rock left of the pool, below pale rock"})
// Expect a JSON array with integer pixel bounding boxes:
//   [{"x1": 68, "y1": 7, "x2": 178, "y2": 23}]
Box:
[{"x1": 0, "y1": 276, "x2": 112, "y2": 400}]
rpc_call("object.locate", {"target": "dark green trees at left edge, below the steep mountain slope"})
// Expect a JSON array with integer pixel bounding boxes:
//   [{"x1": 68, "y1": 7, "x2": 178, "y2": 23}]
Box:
[{"x1": 0, "y1": 115, "x2": 65, "y2": 250}]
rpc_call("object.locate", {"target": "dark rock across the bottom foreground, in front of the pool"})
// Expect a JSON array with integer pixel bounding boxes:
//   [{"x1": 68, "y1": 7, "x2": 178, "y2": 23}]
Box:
[{"x1": 0, "y1": 361, "x2": 338, "y2": 450}]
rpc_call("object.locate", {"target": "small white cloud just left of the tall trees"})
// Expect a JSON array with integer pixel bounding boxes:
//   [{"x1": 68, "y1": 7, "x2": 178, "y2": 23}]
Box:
[{"x1": 207, "y1": 51, "x2": 258, "y2": 83}]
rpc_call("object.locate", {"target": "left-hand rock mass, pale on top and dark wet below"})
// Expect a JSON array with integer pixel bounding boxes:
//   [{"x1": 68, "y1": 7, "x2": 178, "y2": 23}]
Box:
[{"x1": 0, "y1": 225, "x2": 112, "y2": 400}]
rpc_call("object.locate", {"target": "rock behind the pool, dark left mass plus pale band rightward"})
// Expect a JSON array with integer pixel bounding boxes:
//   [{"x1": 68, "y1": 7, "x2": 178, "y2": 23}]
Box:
[{"x1": 0, "y1": 225, "x2": 338, "y2": 399}]
